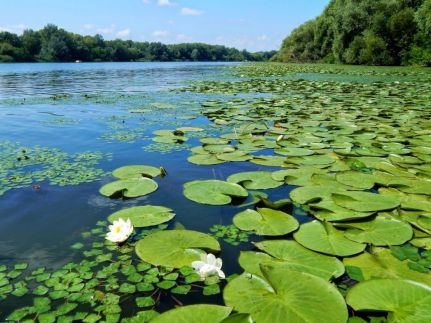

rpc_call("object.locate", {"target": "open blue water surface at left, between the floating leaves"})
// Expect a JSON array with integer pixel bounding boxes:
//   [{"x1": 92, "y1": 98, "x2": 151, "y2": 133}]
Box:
[{"x1": 0, "y1": 63, "x2": 286, "y2": 321}]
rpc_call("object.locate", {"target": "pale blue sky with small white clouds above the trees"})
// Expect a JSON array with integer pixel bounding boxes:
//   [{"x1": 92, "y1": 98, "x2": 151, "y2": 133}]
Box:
[{"x1": 0, "y1": 0, "x2": 329, "y2": 51}]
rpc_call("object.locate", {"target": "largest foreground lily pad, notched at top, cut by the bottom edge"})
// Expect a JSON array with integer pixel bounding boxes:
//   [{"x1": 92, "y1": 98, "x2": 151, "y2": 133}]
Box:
[{"x1": 223, "y1": 265, "x2": 347, "y2": 323}]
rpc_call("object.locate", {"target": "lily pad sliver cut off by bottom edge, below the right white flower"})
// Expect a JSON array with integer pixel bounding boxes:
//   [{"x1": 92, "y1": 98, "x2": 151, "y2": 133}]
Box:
[{"x1": 151, "y1": 304, "x2": 232, "y2": 323}]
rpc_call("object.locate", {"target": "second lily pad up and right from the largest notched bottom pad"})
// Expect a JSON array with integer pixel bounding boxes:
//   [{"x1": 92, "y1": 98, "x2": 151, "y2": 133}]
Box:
[{"x1": 293, "y1": 221, "x2": 366, "y2": 257}]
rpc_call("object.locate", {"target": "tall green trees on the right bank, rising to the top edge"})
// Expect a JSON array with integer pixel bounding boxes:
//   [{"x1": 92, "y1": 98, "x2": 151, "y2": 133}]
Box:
[{"x1": 273, "y1": 0, "x2": 431, "y2": 66}]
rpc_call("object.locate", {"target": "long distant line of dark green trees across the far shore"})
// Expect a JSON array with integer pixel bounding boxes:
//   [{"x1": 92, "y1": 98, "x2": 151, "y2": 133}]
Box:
[{"x1": 0, "y1": 24, "x2": 275, "y2": 62}]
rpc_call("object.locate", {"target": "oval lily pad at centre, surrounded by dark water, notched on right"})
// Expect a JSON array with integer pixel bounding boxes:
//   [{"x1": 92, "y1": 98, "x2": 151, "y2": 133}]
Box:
[{"x1": 184, "y1": 180, "x2": 248, "y2": 205}]
